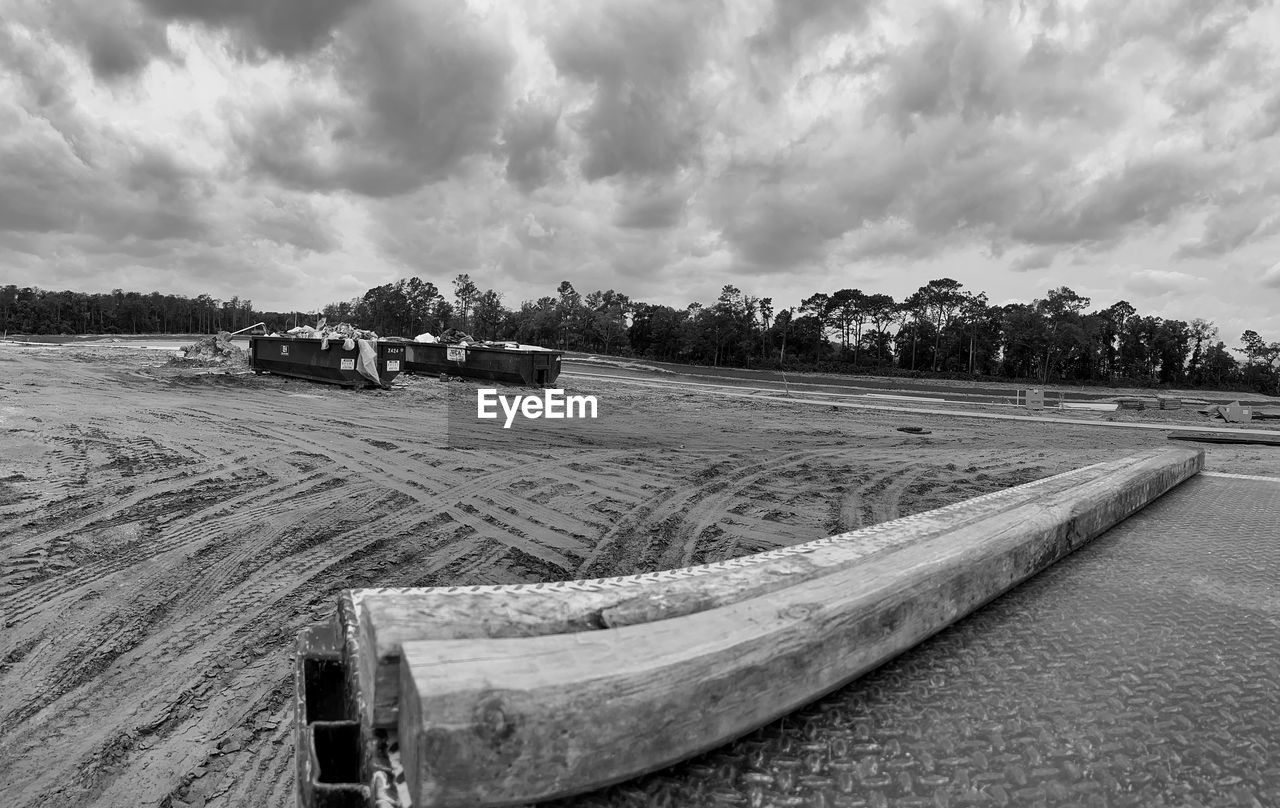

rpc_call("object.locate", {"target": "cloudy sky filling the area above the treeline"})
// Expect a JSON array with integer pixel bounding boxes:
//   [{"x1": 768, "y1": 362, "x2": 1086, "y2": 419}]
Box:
[{"x1": 0, "y1": 0, "x2": 1280, "y2": 342}]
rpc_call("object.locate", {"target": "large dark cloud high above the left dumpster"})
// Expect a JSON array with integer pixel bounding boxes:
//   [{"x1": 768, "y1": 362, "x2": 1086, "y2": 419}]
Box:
[{"x1": 237, "y1": 0, "x2": 513, "y2": 197}]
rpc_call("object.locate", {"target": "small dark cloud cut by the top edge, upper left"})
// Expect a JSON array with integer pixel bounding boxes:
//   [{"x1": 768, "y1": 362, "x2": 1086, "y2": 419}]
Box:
[{"x1": 140, "y1": 0, "x2": 368, "y2": 55}]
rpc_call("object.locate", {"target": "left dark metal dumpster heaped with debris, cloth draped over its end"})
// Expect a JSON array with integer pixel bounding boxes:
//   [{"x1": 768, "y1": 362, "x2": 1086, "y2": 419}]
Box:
[{"x1": 248, "y1": 337, "x2": 404, "y2": 387}]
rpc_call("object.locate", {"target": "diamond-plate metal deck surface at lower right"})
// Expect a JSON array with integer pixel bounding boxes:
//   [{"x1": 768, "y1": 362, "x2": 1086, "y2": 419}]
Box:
[{"x1": 543, "y1": 476, "x2": 1280, "y2": 808}]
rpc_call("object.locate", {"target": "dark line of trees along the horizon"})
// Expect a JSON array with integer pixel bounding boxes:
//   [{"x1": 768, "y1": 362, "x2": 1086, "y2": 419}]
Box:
[{"x1": 0, "y1": 274, "x2": 1280, "y2": 394}]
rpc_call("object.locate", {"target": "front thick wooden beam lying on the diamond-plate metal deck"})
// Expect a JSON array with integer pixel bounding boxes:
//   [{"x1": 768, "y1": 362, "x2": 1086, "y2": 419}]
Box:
[{"x1": 398, "y1": 451, "x2": 1203, "y2": 807}]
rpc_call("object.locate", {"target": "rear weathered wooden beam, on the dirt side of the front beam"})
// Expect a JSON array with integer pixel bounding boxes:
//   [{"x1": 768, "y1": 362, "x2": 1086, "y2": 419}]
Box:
[{"x1": 352, "y1": 449, "x2": 1203, "y2": 727}]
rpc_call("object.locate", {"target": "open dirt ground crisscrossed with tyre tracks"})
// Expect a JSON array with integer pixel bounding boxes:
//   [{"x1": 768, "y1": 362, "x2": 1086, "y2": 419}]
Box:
[{"x1": 0, "y1": 344, "x2": 1280, "y2": 808}]
